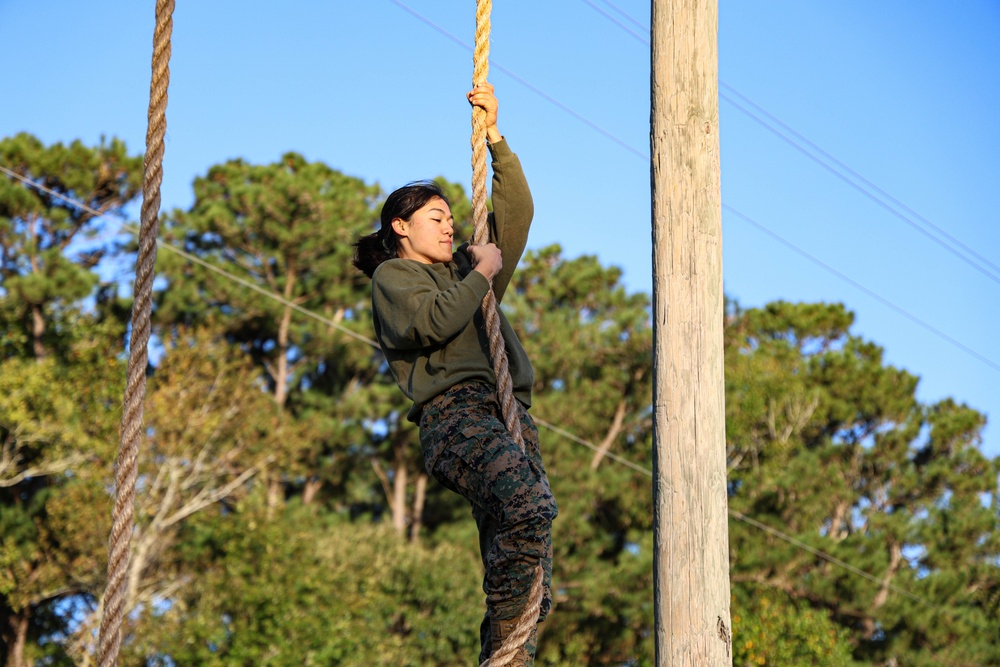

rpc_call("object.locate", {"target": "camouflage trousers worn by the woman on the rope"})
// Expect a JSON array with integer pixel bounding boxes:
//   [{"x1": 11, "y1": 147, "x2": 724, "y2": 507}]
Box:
[{"x1": 420, "y1": 383, "x2": 558, "y2": 660}]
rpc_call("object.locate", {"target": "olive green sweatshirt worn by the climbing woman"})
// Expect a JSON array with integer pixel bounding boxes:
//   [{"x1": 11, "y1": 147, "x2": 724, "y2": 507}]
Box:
[{"x1": 372, "y1": 140, "x2": 534, "y2": 422}]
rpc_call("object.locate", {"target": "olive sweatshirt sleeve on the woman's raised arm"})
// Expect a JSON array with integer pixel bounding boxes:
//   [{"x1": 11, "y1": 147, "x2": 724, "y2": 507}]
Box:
[{"x1": 489, "y1": 139, "x2": 535, "y2": 301}]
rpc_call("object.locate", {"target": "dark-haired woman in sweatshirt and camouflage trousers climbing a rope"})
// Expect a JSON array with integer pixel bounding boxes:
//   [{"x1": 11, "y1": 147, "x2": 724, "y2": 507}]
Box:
[{"x1": 354, "y1": 83, "x2": 558, "y2": 665}]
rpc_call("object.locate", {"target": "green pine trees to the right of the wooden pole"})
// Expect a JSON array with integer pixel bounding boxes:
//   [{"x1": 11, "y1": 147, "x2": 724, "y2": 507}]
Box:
[{"x1": 726, "y1": 303, "x2": 1000, "y2": 665}]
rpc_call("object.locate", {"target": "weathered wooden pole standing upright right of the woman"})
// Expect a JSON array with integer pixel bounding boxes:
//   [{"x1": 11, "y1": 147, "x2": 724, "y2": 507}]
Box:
[{"x1": 650, "y1": 0, "x2": 732, "y2": 667}]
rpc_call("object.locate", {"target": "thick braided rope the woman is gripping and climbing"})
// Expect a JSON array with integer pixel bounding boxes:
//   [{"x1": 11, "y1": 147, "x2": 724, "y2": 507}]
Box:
[{"x1": 472, "y1": 0, "x2": 543, "y2": 667}]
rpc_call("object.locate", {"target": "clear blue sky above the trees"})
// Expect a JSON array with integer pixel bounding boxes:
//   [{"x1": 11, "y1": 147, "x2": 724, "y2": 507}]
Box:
[{"x1": 0, "y1": 0, "x2": 1000, "y2": 455}]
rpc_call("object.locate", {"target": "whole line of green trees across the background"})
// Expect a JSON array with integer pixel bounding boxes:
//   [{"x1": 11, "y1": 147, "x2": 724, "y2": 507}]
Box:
[{"x1": 0, "y1": 134, "x2": 1000, "y2": 667}]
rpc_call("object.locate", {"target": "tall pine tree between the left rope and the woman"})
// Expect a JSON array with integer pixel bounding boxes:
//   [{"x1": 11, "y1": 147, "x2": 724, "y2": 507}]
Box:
[{"x1": 150, "y1": 153, "x2": 415, "y2": 506}]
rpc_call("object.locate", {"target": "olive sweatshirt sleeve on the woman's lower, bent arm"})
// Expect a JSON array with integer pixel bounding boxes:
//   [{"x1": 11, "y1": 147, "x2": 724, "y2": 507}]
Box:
[{"x1": 372, "y1": 259, "x2": 490, "y2": 350}]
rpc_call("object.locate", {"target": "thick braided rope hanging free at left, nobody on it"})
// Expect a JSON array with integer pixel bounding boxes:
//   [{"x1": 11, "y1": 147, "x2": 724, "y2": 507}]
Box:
[{"x1": 99, "y1": 0, "x2": 174, "y2": 667}]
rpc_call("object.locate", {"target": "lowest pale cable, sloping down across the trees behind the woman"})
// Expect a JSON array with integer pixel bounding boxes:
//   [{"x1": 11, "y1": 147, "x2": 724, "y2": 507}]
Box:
[{"x1": 0, "y1": 165, "x2": 981, "y2": 629}]
